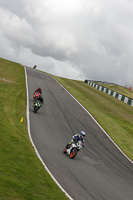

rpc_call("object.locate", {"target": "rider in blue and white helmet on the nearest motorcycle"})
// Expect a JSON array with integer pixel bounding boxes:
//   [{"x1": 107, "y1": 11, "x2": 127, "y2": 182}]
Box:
[{"x1": 65, "y1": 131, "x2": 86, "y2": 149}]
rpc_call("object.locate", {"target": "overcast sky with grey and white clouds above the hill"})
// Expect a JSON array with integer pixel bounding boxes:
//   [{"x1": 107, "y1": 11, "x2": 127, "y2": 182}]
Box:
[{"x1": 0, "y1": 0, "x2": 133, "y2": 85}]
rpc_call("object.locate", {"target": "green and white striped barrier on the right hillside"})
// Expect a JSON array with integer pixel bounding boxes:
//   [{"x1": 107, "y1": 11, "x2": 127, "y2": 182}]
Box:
[{"x1": 85, "y1": 80, "x2": 133, "y2": 106}]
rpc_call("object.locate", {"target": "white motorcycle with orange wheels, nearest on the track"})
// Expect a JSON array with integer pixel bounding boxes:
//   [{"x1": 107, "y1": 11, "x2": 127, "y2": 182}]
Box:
[{"x1": 63, "y1": 140, "x2": 84, "y2": 159}]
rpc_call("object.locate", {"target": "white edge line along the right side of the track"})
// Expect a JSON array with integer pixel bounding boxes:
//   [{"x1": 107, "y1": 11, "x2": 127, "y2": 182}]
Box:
[{"x1": 52, "y1": 77, "x2": 133, "y2": 164}]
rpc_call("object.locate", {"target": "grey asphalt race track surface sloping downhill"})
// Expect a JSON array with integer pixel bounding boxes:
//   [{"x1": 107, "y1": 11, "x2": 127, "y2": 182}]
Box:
[{"x1": 26, "y1": 67, "x2": 133, "y2": 200}]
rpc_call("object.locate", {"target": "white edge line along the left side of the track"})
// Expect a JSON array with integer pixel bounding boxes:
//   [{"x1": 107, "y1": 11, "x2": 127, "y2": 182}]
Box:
[{"x1": 24, "y1": 66, "x2": 73, "y2": 200}]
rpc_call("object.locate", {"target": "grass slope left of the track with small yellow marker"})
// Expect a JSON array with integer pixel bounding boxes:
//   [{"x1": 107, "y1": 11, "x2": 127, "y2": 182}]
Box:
[{"x1": 0, "y1": 58, "x2": 68, "y2": 200}]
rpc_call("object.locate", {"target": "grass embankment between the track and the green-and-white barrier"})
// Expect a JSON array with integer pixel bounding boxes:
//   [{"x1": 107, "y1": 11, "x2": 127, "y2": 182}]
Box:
[{"x1": 54, "y1": 76, "x2": 133, "y2": 160}]
